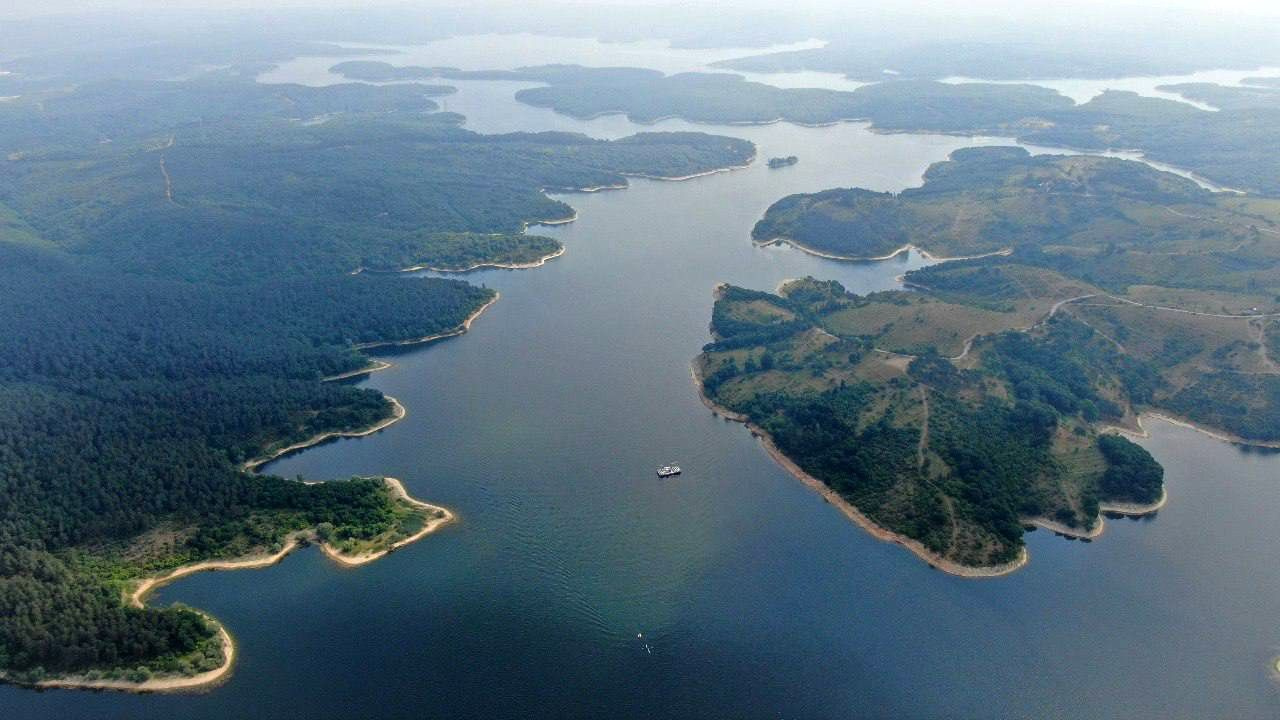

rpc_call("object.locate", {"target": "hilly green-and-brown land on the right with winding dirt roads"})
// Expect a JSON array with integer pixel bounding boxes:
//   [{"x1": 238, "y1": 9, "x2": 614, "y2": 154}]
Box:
[{"x1": 695, "y1": 147, "x2": 1280, "y2": 574}]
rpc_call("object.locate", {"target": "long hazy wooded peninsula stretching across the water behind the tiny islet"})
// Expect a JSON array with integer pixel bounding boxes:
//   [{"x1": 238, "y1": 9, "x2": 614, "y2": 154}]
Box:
[{"x1": 339, "y1": 61, "x2": 1280, "y2": 196}]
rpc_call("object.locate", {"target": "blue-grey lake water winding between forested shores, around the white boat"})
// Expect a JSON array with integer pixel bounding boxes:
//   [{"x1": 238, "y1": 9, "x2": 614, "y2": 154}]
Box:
[{"x1": 10, "y1": 35, "x2": 1280, "y2": 719}]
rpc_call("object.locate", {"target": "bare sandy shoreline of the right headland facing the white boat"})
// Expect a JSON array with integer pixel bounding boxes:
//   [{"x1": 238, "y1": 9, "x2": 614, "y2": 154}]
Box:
[{"x1": 690, "y1": 359, "x2": 1030, "y2": 579}]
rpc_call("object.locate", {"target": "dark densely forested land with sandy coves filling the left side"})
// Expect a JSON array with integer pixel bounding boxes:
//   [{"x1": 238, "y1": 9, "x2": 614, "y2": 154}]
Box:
[{"x1": 0, "y1": 69, "x2": 755, "y2": 689}]
